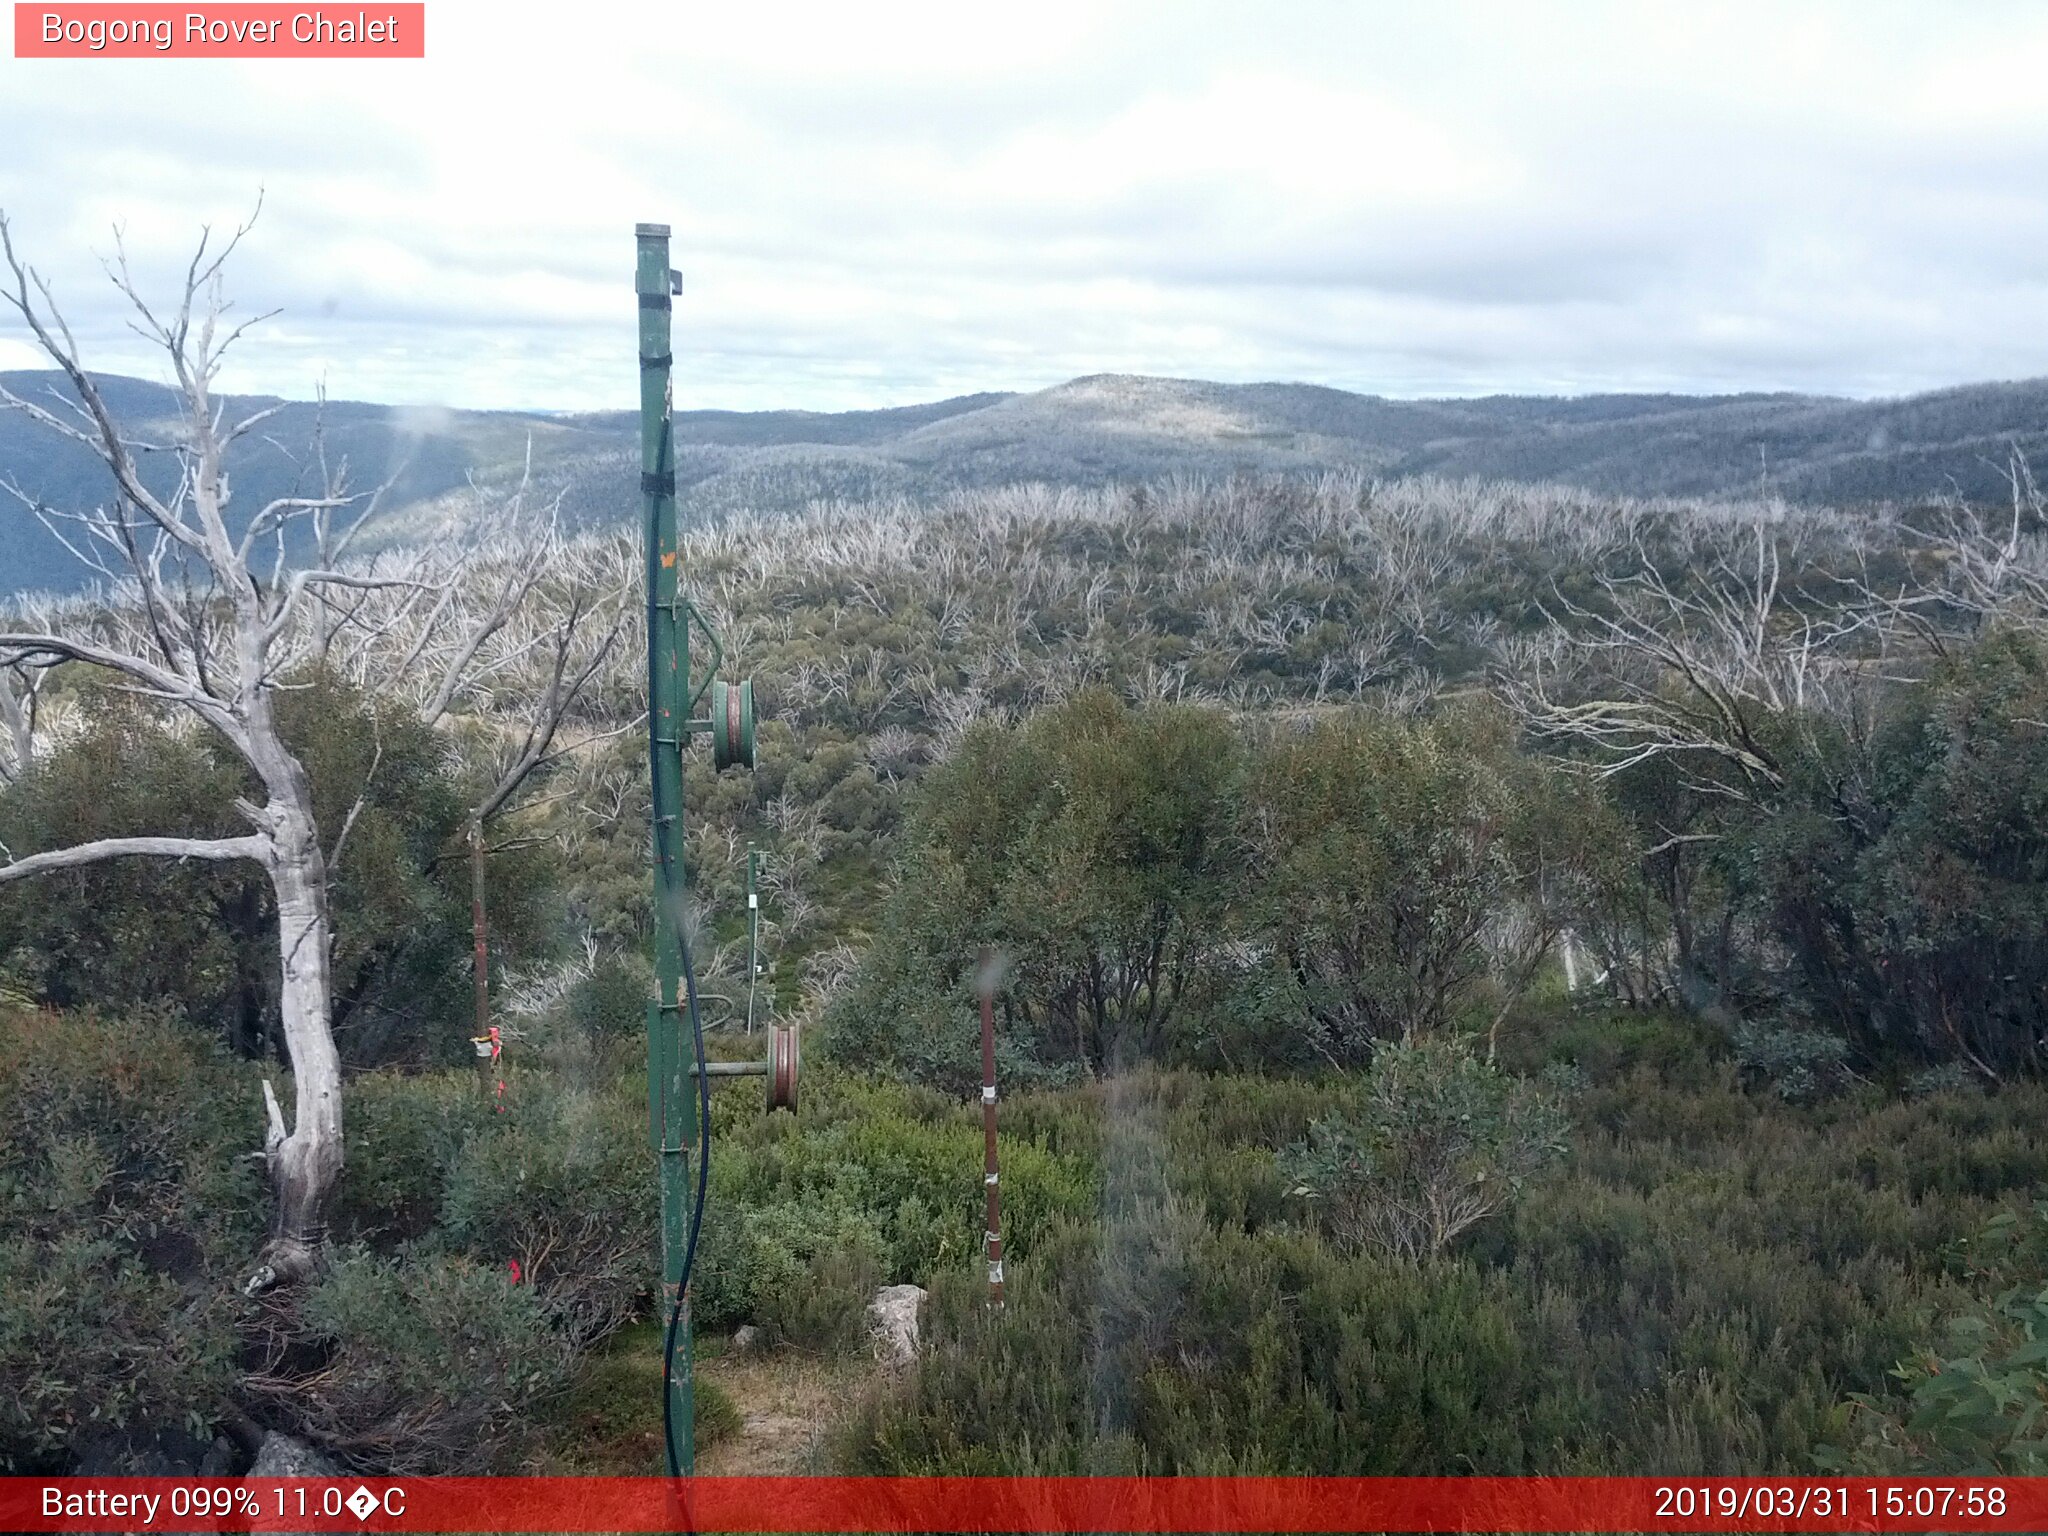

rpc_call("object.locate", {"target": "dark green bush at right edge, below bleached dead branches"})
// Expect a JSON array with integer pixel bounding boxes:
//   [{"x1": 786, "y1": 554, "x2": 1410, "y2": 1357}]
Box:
[{"x1": 1737, "y1": 629, "x2": 2048, "y2": 1077}]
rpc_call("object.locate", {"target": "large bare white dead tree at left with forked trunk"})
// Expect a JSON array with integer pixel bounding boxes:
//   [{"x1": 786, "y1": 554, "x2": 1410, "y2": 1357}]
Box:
[{"x1": 0, "y1": 207, "x2": 364, "y2": 1286}]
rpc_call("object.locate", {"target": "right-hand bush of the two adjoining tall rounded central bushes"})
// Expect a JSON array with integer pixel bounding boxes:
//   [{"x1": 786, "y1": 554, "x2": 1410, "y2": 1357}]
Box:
[{"x1": 1241, "y1": 709, "x2": 1622, "y2": 1065}]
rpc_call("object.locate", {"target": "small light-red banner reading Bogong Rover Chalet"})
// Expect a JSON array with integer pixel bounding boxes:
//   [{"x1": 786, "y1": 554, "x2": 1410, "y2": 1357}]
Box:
[{"x1": 14, "y1": 0, "x2": 426, "y2": 59}]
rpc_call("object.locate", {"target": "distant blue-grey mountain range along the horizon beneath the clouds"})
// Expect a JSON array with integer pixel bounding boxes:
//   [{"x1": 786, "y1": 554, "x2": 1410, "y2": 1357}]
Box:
[{"x1": 0, "y1": 373, "x2": 2048, "y2": 590}]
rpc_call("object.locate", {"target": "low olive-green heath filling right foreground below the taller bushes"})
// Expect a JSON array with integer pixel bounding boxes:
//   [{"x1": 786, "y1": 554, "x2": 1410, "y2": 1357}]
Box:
[{"x1": 836, "y1": 1048, "x2": 2048, "y2": 1475}]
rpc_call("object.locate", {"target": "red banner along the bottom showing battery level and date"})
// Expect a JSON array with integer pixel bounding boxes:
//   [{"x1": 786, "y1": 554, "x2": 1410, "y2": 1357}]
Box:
[{"x1": 0, "y1": 1477, "x2": 2048, "y2": 1532}]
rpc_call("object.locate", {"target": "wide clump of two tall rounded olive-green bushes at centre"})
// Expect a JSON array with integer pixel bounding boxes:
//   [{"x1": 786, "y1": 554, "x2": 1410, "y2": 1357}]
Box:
[{"x1": 825, "y1": 690, "x2": 1626, "y2": 1092}]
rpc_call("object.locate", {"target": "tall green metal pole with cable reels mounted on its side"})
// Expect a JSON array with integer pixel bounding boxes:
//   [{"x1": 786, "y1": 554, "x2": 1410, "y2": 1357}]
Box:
[{"x1": 633, "y1": 223, "x2": 696, "y2": 1473}]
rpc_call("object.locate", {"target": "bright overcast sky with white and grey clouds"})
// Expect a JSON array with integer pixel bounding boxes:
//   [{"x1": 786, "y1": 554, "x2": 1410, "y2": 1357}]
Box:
[{"x1": 0, "y1": 0, "x2": 2048, "y2": 410}]
